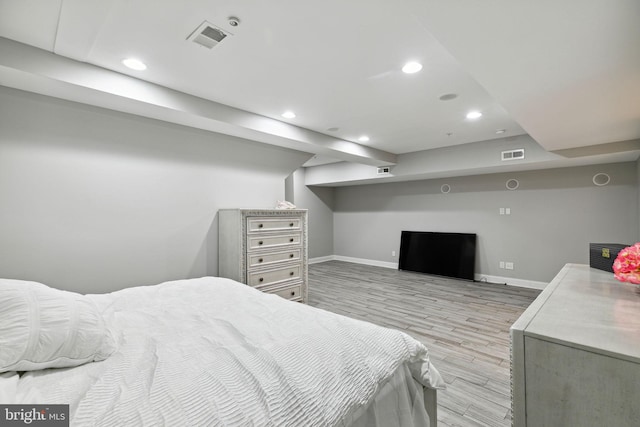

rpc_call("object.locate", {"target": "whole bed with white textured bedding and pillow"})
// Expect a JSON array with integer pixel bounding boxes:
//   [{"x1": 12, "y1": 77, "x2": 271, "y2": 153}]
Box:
[{"x1": 0, "y1": 277, "x2": 444, "y2": 427}]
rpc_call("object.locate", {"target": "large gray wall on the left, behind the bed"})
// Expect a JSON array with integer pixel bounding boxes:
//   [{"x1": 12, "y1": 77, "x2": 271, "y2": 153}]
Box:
[{"x1": 0, "y1": 87, "x2": 310, "y2": 293}]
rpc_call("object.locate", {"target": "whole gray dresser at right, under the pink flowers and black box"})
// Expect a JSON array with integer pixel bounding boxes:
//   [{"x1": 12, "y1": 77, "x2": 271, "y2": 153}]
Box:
[{"x1": 511, "y1": 264, "x2": 640, "y2": 427}]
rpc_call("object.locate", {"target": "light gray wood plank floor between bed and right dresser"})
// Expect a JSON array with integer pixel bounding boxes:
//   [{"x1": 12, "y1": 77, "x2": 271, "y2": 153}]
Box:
[{"x1": 309, "y1": 261, "x2": 540, "y2": 427}]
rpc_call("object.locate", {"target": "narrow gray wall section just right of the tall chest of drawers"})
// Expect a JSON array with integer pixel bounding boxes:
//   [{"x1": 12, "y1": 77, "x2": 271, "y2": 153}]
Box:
[{"x1": 287, "y1": 168, "x2": 334, "y2": 258}]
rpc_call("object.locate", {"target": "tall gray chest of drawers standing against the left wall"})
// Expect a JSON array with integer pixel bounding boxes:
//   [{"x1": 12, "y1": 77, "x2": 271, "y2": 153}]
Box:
[{"x1": 218, "y1": 209, "x2": 308, "y2": 302}]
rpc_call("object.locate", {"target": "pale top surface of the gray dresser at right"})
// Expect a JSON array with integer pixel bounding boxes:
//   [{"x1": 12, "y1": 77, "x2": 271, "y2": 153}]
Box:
[{"x1": 513, "y1": 264, "x2": 640, "y2": 363}]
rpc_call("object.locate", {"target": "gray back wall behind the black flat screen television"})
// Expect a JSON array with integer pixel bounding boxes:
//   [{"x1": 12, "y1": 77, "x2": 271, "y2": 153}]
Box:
[{"x1": 334, "y1": 162, "x2": 640, "y2": 282}]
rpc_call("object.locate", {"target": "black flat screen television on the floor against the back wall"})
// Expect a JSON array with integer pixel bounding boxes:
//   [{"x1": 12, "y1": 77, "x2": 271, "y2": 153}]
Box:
[{"x1": 398, "y1": 231, "x2": 476, "y2": 280}]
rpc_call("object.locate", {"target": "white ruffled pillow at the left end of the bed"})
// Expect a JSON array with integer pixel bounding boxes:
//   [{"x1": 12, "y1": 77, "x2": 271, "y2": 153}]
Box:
[{"x1": 0, "y1": 279, "x2": 116, "y2": 372}]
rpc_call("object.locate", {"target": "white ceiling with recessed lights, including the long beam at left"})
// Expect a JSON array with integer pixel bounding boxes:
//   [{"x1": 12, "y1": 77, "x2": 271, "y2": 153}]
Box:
[{"x1": 0, "y1": 0, "x2": 640, "y2": 172}]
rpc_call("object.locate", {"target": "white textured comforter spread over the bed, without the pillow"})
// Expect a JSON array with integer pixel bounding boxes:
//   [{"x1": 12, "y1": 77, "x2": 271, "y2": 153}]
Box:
[{"x1": 0, "y1": 277, "x2": 443, "y2": 426}]
